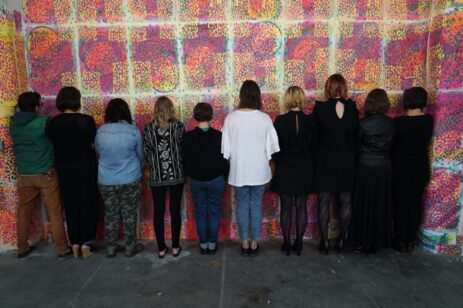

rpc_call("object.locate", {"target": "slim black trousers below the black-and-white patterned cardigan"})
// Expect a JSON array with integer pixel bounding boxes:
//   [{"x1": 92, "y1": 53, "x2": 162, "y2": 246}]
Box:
[{"x1": 151, "y1": 183, "x2": 183, "y2": 250}]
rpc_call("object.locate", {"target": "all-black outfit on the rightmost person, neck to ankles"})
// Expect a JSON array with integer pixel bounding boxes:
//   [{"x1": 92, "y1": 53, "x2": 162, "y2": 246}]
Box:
[{"x1": 392, "y1": 114, "x2": 433, "y2": 245}]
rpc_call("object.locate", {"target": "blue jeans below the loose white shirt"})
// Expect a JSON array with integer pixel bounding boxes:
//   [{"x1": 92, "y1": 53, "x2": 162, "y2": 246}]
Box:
[{"x1": 234, "y1": 185, "x2": 265, "y2": 241}]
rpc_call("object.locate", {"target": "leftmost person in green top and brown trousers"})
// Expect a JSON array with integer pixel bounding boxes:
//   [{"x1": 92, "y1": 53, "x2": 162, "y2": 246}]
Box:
[{"x1": 10, "y1": 92, "x2": 72, "y2": 258}]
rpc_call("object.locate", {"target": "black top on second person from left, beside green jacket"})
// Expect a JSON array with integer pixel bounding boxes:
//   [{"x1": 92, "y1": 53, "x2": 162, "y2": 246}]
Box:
[{"x1": 48, "y1": 113, "x2": 96, "y2": 167}]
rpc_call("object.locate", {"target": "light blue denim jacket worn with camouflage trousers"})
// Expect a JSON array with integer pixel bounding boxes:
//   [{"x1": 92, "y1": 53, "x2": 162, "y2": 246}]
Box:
[{"x1": 95, "y1": 121, "x2": 143, "y2": 185}]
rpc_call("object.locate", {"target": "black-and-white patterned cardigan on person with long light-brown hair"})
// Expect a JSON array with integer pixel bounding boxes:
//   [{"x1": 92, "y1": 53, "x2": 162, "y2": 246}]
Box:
[{"x1": 143, "y1": 122, "x2": 185, "y2": 186}]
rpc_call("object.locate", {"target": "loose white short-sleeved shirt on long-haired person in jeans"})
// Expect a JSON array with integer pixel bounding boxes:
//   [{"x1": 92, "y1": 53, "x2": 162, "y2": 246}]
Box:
[{"x1": 222, "y1": 110, "x2": 280, "y2": 187}]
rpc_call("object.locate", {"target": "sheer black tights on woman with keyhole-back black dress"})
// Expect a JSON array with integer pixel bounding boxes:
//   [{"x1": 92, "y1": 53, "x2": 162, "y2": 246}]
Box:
[{"x1": 318, "y1": 192, "x2": 352, "y2": 240}]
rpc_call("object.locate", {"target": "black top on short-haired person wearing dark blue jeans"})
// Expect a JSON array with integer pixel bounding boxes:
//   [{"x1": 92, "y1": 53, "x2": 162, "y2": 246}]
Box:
[{"x1": 183, "y1": 127, "x2": 228, "y2": 181}]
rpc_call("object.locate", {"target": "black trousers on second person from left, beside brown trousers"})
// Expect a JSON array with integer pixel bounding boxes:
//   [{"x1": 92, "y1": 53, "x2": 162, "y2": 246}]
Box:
[{"x1": 57, "y1": 163, "x2": 98, "y2": 245}]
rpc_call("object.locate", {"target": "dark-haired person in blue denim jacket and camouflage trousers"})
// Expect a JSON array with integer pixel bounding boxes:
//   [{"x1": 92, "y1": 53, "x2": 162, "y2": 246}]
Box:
[{"x1": 95, "y1": 98, "x2": 144, "y2": 258}]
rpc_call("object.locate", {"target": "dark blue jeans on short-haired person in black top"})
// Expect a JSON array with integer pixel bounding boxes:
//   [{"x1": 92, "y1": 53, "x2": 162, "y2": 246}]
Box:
[{"x1": 190, "y1": 175, "x2": 225, "y2": 249}]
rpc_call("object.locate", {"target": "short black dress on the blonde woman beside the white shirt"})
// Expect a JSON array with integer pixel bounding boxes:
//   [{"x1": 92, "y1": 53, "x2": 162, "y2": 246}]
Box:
[{"x1": 271, "y1": 111, "x2": 315, "y2": 195}]
